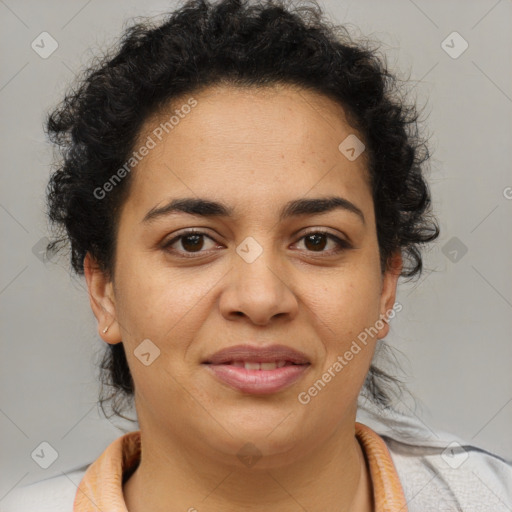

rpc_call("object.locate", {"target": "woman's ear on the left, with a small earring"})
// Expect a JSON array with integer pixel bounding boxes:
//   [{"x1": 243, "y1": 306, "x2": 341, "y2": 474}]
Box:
[{"x1": 84, "y1": 252, "x2": 122, "y2": 345}]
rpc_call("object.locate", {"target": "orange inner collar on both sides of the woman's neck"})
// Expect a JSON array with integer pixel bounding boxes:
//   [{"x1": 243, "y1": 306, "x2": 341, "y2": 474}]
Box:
[{"x1": 73, "y1": 422, "x2": 407, "y2": 512}]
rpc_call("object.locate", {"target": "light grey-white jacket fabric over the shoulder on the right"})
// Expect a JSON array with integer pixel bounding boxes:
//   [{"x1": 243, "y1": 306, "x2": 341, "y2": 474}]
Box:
[{"x1": 358, "y1": 400, "x2": 512, "y2": 512}]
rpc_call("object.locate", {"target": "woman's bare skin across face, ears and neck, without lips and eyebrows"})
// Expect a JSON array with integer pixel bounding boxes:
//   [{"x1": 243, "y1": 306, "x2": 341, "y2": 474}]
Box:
[{"x1": 84, "y1": 86, "x2": 401, "y2": 512}]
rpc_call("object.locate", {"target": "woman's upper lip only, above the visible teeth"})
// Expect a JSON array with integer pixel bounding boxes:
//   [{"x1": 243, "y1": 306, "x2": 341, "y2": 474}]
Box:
[{"x1": 204, "y1": 345, "x2": 309, "y2": 364}]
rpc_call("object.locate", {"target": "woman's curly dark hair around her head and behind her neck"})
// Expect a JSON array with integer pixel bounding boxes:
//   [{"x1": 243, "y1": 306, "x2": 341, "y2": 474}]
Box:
[{"x1": 46, "y1": 0, "x2": 439, "y2": 417}]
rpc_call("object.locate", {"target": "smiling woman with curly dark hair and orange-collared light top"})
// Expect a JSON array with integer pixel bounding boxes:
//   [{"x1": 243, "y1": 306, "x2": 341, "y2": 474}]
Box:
[{"x1": 7, "y1": 0, "x2": 512, "y2": 512}]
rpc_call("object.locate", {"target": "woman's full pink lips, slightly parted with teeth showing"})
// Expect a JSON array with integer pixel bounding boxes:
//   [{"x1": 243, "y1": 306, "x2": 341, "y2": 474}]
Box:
[{"x1": 203, "y1": 345, "x2": 311, "y2": 395}]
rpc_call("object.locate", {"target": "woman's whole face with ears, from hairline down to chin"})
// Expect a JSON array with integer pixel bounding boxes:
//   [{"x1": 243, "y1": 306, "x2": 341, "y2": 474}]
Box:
[{"x1": 86, "y1": 83, "x2": 397, "y2": 465}]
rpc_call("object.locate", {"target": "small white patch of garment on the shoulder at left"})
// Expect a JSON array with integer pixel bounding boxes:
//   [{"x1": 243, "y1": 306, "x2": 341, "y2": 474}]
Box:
[{"x1": 0, "y1": 465, "x2": 88, "y2": 512}]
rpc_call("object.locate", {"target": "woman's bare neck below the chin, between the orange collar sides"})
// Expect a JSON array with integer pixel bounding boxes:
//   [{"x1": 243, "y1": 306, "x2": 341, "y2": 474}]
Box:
[{"x1": 123, "y1": 422, "x2": 374, "y2": 512}]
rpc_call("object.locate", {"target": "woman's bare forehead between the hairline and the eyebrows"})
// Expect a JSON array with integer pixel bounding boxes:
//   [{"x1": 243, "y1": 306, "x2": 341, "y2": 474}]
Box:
[{"x1": 124, "y1": 86, "x2": 369, "y2": 219}]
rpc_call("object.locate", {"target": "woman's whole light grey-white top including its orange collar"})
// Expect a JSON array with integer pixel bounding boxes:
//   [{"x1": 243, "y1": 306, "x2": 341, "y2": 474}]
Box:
[{"x1": 0, "y1": 403, "x2": 512, "y2": 512}]
